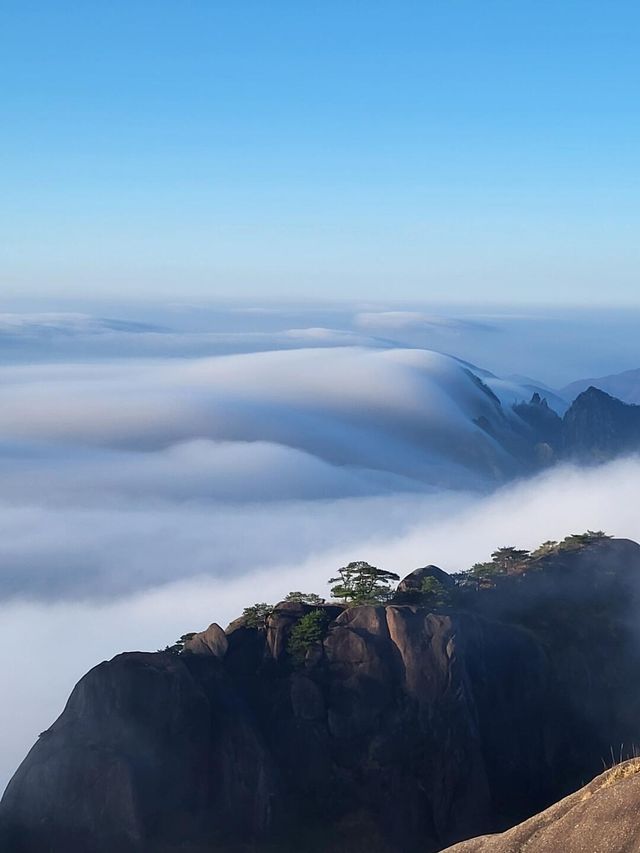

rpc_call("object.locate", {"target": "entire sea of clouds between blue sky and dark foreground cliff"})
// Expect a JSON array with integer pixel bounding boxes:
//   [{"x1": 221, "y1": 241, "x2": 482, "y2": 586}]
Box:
[{"x1": 0, "y1": 306, "x2": 640, "y2": 787}]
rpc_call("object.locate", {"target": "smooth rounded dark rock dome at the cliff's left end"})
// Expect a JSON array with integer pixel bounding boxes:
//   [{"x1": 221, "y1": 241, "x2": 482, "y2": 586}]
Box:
[{"x1": 0, "y1": 652, "x2": 277, "y2": 853}]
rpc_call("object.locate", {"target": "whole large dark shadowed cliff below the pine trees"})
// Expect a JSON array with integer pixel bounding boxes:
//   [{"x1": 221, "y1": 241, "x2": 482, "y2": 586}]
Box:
[{"x1": 0, "y1": 539, "x2": 640, "y2": 853}]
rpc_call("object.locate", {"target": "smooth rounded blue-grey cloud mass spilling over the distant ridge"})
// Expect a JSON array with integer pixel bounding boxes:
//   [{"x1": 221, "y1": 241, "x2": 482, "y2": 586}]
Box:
[{"x1": 0, "y1": 348, "x2": 544, "y2": 599}]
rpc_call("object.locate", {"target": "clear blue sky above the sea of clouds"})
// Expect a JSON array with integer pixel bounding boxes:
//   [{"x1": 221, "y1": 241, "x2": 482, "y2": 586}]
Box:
[{"x1": 0, "y1": 0, "x2": 640, "y2": 303}]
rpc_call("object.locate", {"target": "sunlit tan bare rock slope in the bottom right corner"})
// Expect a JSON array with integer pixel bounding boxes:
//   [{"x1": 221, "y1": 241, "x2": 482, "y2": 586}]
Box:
[{"x1": 446, "y1": 759, "x2": 640, "y2": 853}]
